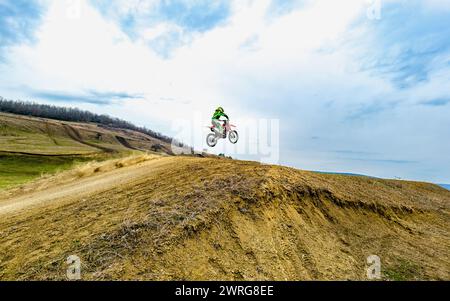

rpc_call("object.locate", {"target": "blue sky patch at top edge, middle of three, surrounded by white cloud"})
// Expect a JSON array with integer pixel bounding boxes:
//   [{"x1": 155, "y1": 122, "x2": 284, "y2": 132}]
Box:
[{"x1": 91, "y1": 0, "x2": 231, "y2": 59}]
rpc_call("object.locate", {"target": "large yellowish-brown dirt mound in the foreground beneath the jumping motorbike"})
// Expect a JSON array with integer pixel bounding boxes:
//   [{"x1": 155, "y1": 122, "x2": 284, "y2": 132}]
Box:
[{"x1": 0, "y1": 154, "x2": 450, "y2": 280}]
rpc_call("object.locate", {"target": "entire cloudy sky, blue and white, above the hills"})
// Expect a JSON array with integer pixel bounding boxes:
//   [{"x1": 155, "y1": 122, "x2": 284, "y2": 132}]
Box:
[{"x1": 0, "y1": 0, "x2": 450, "y2": 183}]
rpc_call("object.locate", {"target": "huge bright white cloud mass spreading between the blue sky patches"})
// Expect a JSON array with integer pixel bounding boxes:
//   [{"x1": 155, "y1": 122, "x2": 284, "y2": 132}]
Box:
[{"x1": 0, "y1": 0, "x2": 450, "y2": 182}]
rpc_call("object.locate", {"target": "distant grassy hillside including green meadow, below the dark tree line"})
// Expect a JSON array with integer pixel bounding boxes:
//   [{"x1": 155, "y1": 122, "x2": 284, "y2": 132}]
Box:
[{"x1": 0, "y1": 113, "x2": 174, "y2": 190}]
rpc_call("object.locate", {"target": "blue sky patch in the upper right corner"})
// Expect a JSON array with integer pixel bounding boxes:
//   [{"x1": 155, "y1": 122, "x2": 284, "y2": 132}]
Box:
[{"x1": 355, "y1": 0, "x2": 450, "y2": 89}]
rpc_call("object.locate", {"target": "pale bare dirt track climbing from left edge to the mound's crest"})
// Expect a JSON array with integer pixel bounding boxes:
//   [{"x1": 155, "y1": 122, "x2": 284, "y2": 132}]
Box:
[{"x1": 0, "y1": 157, "x2": 173, "y2": 216}]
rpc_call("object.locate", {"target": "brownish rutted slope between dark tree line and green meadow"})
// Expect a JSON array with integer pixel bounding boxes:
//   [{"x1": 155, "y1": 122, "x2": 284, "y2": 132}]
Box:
[{"x1": 0, "y1": 113, "x2": 170, "y2": 156}]
